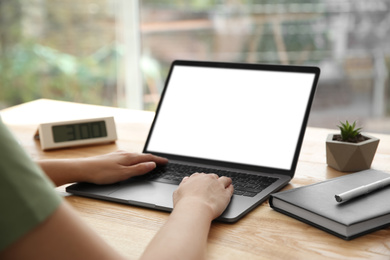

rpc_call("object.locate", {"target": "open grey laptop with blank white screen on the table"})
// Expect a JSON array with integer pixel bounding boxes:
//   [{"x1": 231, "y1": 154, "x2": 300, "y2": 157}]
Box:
[{"x1": 66, "y1": 60, "x2": 320, "y2": 222}]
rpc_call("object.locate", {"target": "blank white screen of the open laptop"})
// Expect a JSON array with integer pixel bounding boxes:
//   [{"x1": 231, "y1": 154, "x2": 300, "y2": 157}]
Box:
[{"x1": 148, "y1": 65, "x2": 315, "y2": 170}]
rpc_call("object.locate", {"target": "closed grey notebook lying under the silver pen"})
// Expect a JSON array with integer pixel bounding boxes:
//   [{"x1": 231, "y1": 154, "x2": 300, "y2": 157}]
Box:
[{"x1": 269, "y1": 170, "x2": 390, "y2": 240}]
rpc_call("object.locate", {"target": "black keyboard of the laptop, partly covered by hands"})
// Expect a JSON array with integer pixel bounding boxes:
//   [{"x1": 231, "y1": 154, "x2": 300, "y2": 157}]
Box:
[{"x1": 137, "y1": 163, "x2": 277, "y2": 197}]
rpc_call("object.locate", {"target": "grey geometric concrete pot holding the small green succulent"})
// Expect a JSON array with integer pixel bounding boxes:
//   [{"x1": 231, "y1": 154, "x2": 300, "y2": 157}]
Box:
[{"x1": 326, "y1": 134, "x2": 379, "y2": 172}]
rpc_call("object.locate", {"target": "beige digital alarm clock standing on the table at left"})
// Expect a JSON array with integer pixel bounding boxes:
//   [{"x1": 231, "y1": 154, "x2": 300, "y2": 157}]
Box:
[{"x1": 34, "y1": 117, "x2": 117, "y2": 150}]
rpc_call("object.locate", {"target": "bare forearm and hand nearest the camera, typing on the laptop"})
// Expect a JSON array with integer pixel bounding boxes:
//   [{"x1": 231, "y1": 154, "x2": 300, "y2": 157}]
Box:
[{"x1": 142, "y1": 173, "x2": 233, "y2": 259}]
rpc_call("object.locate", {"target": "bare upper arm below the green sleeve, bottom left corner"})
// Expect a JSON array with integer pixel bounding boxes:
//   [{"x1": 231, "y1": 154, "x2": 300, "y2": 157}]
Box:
[{"x1": 0, "y1": 201, "x2": 124, "y2": 260}]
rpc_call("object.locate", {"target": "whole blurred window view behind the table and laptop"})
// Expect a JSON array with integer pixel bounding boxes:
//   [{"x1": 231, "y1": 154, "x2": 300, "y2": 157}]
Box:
[{"x1": 0, "y1": 0, "x2": 390, "y2": 133}]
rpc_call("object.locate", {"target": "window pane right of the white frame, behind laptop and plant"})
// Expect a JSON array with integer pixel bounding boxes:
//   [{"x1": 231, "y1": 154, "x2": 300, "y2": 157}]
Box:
[{"x1": 140, "y1": 0, "x2": 390, "y2": 133}]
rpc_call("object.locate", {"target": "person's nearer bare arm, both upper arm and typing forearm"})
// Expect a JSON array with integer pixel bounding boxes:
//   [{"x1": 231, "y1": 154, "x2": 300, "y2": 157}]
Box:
[{"x1": 0, "y1": 174, "x2": 233, "y2": 260}]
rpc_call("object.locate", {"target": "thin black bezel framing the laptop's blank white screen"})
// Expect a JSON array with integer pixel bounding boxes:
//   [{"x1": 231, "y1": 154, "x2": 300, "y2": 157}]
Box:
[{"x1": 143, "y1": 60, "x2": 320, "y2": 178}]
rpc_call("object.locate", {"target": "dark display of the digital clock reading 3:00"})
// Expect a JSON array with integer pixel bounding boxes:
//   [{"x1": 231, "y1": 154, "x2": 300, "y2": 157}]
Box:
[{"x1": 52, "y1": 121, "x2": 107, "y2": 143}]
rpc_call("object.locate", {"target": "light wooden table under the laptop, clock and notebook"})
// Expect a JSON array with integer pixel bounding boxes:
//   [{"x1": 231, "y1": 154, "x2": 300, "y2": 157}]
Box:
[{"x1": 0, "y1": 99, "x2": 390, "y2": 259}]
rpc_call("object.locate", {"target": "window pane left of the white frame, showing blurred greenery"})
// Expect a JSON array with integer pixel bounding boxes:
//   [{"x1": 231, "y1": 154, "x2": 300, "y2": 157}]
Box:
[{"x1": 0, "y1": 0, "x2": 121, "y2": 107}]
